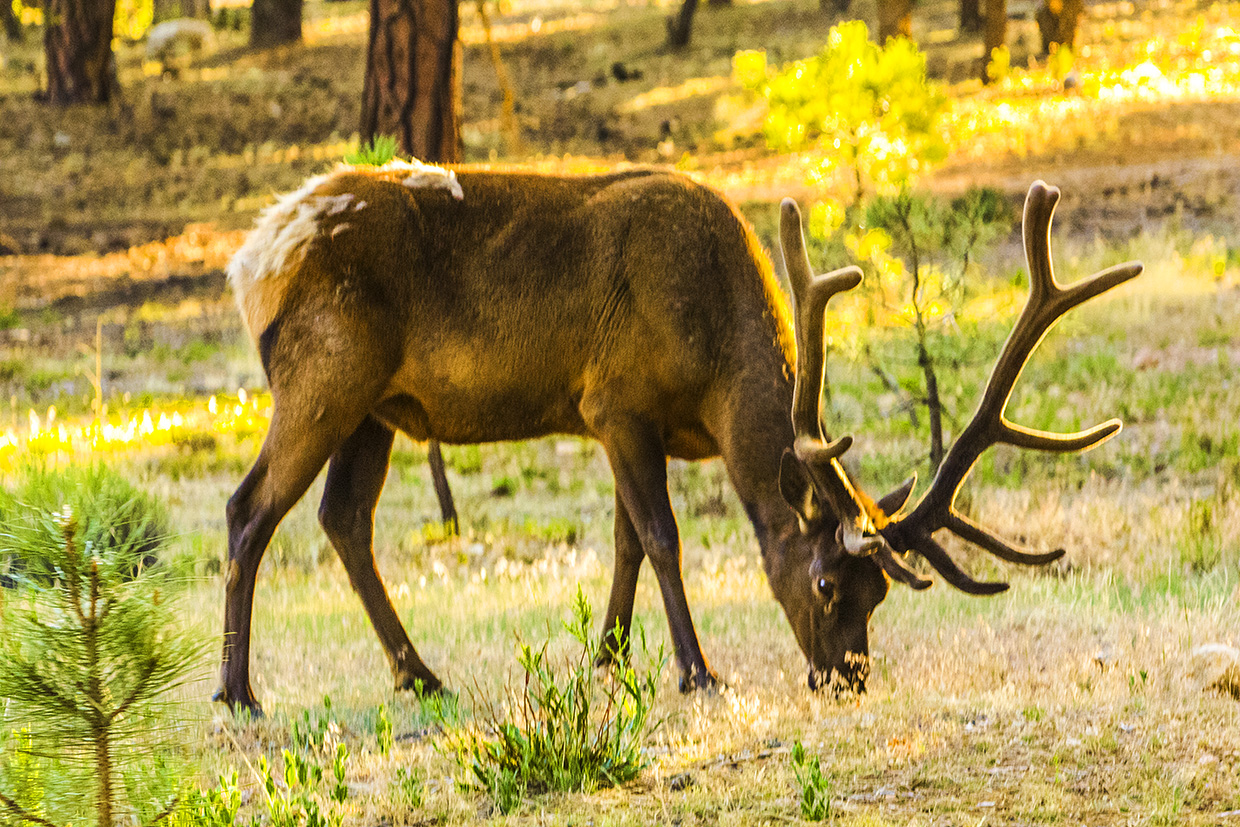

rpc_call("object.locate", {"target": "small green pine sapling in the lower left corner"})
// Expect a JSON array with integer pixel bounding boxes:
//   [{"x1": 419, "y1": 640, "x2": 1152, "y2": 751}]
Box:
[{"x1": 0, "y1": 498, "x2": 200, "y2": 827}]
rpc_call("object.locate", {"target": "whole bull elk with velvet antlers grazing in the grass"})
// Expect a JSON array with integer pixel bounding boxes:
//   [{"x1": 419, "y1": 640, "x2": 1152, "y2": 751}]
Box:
[{"x1": 216, "y1": 164, "x2": 1141, "y2": 712}]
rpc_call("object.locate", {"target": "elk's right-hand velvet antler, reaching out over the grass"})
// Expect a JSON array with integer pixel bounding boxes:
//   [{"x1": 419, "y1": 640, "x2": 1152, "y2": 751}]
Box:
[{"x1": 878, "y1": 181, "x2": 1142, "y2": 594}]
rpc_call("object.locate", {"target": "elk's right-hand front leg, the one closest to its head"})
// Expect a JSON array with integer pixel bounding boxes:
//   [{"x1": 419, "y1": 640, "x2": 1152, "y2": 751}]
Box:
[{"x1": 601, "y1": 420, "x2": 719, "y2": 692}]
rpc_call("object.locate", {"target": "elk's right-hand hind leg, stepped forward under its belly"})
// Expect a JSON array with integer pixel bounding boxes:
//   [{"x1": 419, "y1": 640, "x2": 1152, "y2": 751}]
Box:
[{"x1": 319, "y1": 417, "x2": 443, "y2": 692}]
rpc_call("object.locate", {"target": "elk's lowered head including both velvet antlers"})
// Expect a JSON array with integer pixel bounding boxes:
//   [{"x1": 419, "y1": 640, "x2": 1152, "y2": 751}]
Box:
[{"x1": 773, "y1": 181, "x2": 1142, "y2": 691}]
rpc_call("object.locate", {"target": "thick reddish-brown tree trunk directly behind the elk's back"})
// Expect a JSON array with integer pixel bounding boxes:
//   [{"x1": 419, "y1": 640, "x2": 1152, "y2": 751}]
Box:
[{"x1": 361, "y1": 0, "x2": 461, "y2": 164}]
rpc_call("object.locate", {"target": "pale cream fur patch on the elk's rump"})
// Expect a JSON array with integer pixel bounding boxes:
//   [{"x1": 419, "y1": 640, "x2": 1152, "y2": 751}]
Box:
[{"x1": 228, "y1": 160, "x2": 465, "y2": 341}]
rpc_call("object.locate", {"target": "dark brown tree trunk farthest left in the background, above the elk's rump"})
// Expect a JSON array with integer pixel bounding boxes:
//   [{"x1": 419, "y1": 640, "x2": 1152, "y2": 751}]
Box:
[{"x1": 43, "y1": 0, "x2": 117, "y2": 105}]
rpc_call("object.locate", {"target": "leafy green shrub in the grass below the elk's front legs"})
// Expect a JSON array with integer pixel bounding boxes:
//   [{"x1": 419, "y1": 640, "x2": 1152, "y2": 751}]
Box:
[{"x1": 449, "y1": 589, "x2": 663, "y2": 812}]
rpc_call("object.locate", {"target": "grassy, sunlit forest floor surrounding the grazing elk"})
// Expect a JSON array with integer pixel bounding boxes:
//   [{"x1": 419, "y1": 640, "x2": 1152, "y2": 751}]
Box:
[{"x1": 0, "y1": 0, "x2": 1240, "y2": 826}]
